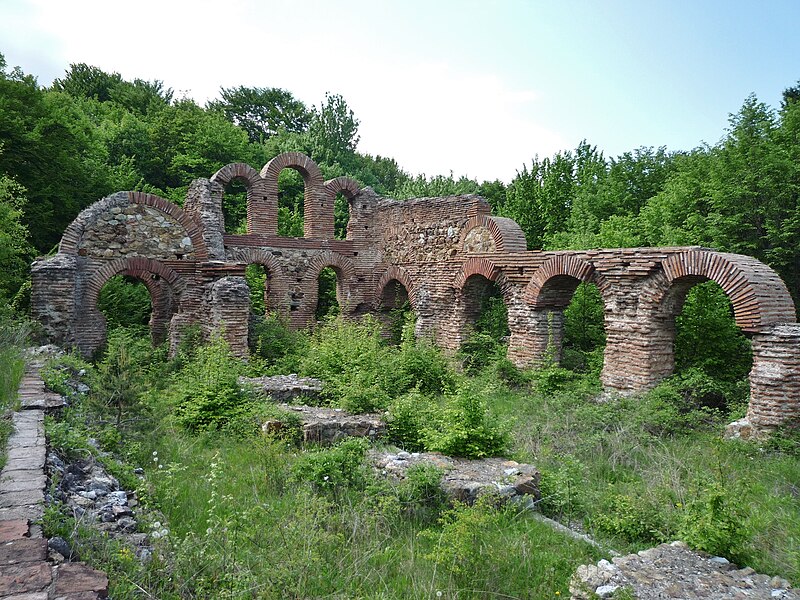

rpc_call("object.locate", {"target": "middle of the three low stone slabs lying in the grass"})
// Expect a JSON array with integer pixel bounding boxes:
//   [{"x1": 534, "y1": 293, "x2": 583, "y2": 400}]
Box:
[{"x1": 261, "y1": 404, "x2": 386, "y2": 444}]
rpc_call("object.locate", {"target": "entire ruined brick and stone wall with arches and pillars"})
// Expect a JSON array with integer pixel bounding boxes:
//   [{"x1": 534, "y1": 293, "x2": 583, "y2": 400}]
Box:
[{"x1": 32, "y1": 152, "x2": 800, "y2": 430}]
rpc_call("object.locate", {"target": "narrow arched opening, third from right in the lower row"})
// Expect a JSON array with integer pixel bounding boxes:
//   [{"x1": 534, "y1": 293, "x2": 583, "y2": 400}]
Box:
[{"x1": 460, "y1": 274, "x2": 510, "y2": 372}]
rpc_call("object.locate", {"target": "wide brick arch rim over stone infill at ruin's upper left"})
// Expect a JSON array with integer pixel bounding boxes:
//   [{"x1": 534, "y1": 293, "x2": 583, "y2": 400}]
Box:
[{"x1": 58, "y1": 192, "x2": 208, "y2": 260}]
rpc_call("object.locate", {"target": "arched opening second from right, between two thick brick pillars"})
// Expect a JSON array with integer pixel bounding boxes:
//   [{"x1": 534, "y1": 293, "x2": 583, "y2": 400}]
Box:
[{"x1": 559, "y1": 282, "x2": 606, "y2": 375}]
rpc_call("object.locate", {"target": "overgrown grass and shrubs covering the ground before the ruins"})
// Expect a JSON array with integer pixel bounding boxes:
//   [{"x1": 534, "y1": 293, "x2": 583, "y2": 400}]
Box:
[{"x1": 40, "y1": 320, "x2": 800, "y2": 598}]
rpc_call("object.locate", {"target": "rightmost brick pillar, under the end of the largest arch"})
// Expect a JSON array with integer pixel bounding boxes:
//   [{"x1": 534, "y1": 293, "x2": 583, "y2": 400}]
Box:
[{"x1": 727, "y1": 324, "x2": 800, "y2": 438}]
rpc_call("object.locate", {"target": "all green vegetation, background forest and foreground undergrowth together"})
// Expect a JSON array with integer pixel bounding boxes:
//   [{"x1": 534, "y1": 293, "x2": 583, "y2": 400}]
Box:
[{"x1": 0, "y1": 56, "x2": 800, "y2": 598}]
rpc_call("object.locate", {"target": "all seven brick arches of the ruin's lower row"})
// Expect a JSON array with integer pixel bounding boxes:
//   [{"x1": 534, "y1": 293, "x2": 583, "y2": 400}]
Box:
[{"x1": 81, "y1": 248, "x2": 795, "y2": 346}]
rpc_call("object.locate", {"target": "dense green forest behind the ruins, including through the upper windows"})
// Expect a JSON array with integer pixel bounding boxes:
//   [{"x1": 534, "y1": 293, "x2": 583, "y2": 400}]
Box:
[{"x1": 0, "y1": 55, "x2": 800, "y2": 316}]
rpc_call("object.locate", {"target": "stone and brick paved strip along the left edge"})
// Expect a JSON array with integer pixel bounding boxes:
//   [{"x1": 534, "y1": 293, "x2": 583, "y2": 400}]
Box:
[{"x1": 0, "y1": 363, "x2": 108, "y2": 600}]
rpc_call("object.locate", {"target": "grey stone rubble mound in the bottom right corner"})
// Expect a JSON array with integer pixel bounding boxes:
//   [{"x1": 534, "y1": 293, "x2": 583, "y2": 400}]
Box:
[{"x1": 569, "y1": 542, "x2": 800, "y2": 600}]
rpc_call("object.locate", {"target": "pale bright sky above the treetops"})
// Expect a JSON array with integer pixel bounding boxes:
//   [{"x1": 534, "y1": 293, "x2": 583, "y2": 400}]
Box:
[{"x1": 0, "y1": 0, "x2": 800, "y2": 182}]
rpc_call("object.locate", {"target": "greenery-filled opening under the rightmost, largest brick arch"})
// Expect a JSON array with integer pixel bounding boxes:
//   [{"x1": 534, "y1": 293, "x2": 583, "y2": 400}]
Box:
[{"x1": 664, "y1": 276, "x2": 753, "y2": 410}]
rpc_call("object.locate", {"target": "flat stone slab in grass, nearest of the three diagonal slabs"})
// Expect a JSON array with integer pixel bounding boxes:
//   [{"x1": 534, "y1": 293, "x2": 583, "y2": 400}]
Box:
[{"x1": 369, "y1": 450, "x2": 540, "y2": 507}]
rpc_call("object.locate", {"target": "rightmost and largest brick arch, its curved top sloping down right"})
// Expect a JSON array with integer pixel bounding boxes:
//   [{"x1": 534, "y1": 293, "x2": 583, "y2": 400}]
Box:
[{"x1": 654, "y1": 250, "x2": 797, "y2": 333}]
